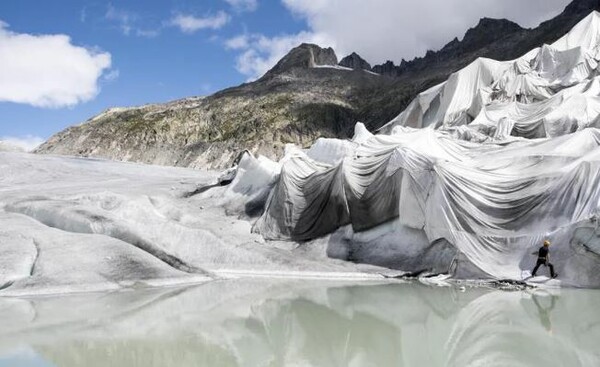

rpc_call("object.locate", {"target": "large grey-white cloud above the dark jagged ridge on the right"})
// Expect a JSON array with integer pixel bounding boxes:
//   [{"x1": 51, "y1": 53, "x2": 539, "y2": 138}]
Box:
[{"x1": 282, "y1": 0, "x2": 571, "y2": 64}]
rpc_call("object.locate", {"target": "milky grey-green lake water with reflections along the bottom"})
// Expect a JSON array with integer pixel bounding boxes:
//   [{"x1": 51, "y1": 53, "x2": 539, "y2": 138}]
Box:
[{"x1": 0, "y1": 281, "x2": 600, "y2": 367}]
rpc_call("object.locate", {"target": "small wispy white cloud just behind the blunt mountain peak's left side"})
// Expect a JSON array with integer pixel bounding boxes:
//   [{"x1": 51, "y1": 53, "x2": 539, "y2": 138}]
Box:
[{"x1": 225, "y1": 32, "x2": 335, "y2": 80}]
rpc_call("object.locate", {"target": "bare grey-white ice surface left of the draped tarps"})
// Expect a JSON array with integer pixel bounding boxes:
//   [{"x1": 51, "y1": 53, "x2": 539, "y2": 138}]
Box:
[{"x1": 0, "y1": 152, "x2": 400, "y2": 295}]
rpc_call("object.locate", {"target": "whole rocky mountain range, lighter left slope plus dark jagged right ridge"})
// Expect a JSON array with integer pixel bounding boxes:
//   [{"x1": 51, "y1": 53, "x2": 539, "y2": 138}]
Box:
[{"x1": 37, "y1": 0, "x2": 600, "y2": 168}]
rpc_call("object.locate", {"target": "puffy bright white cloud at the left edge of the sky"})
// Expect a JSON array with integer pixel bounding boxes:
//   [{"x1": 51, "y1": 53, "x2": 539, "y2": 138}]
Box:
[{"x1": 0, "y1": 21, "x2": 111, "y2": 107}]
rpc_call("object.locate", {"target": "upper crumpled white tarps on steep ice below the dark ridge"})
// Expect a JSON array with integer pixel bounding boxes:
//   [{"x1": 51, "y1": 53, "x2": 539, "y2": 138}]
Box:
[{"x1": 380, "y1": 12, "x2": 600, "y2": 140}]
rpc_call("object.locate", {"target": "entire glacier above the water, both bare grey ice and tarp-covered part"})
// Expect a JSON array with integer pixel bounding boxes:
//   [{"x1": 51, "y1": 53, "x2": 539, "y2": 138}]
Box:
[{"x1": 5, "y1": 12, "x2": 600, "y2": 296}]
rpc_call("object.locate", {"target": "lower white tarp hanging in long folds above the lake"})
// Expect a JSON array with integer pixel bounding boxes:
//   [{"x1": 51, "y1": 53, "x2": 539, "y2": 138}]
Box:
[{"x1": 255, "y1": 124, "x2": 600, "y2": 278}]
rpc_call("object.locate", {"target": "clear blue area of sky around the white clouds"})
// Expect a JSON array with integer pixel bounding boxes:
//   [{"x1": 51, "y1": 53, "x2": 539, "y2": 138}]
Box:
[{"x1": 0, "y1": 0, "x2": 302, "y2": 147}]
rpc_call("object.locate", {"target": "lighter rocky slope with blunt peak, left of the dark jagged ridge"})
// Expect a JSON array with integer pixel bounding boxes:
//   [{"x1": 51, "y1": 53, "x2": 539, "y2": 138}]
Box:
[{"x1": 37, "y1": 44, "x2": 389, "y2": 168}]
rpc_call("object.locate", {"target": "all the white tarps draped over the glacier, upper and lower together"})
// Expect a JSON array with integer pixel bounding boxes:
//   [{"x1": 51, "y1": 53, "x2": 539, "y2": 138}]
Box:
[{"x1": 247, "y1": 12, "x2": 600, "y2": 285}]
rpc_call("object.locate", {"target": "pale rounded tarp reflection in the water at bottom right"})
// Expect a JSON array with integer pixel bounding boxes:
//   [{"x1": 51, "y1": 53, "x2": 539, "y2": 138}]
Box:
[{"x1": 446, "y1": 292, "x2": 600, "y2": 367}]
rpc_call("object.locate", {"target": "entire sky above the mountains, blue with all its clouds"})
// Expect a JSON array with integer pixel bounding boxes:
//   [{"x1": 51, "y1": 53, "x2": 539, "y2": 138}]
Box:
[{"x1": 0, "y1": 0, "x2": 569, "y2": 150}]
